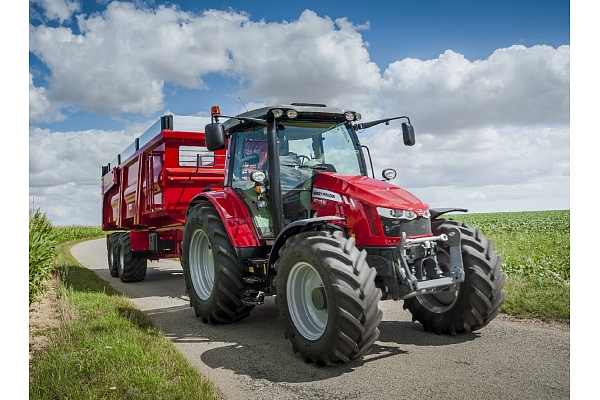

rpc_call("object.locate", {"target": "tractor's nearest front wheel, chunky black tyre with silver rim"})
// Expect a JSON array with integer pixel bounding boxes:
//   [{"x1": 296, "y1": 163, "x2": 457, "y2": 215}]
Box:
[{"x1": 274, "y1": 232, "x2": 382, "y2": 365}]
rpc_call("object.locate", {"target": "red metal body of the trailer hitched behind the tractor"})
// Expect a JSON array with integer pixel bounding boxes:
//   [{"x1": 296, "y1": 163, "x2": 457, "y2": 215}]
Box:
[{"x1": 102, "y1": 126, "x2": 226, "y2": 258}]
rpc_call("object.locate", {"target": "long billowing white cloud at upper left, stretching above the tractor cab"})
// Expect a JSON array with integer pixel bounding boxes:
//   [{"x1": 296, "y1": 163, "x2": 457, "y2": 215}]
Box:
[{"x1": 29, "y1": 2, "x2": 380, "y2": 114}]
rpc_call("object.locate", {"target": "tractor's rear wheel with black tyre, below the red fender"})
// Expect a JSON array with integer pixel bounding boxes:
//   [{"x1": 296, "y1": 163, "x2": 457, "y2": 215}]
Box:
[{"x1": 181, "y1": 202, "x2": 254, "y2": 323}]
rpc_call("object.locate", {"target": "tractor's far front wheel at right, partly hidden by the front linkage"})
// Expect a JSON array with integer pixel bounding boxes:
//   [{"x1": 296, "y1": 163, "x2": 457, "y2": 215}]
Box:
[{"x1": 404, "y1": 220, "x2": 506, "y2": 335}]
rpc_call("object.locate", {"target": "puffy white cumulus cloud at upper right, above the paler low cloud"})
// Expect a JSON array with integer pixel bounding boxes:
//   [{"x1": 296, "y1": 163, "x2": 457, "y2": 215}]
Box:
[{"x1": 381, "y1": 45, "x2": 570, "y2": 133}]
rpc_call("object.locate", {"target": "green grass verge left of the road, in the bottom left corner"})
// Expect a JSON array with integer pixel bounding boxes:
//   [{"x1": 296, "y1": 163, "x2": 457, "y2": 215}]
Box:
[{"x1": 29, "y1": 242, "x2": 218, "y2": 399}]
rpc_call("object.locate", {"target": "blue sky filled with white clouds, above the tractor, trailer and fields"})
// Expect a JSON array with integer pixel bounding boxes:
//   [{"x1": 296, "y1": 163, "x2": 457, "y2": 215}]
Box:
[{"x1": 29, "y1": 0, "x2": 571, "y2": 225}]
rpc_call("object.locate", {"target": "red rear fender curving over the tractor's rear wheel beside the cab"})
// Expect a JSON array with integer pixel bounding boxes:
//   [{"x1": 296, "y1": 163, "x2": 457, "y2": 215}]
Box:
[{"x1": 186, "y1": 187, "x2": 264, "y2": 247}]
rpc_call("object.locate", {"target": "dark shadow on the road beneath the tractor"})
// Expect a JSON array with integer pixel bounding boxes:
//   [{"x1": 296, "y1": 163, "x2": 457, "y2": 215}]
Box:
[{"x1": 141, "y1": 297, "x2": 478, "y2": 383}]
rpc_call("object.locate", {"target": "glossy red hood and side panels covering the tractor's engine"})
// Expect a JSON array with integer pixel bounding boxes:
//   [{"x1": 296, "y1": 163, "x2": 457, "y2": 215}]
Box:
[{"x1": 312, "y1": 172, "x2": 429, "y2": 246}]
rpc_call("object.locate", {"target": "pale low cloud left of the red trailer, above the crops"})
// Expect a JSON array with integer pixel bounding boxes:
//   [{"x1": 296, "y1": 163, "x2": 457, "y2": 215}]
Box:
[{"x1": 29, "y1": 123, "x2": 149, "y2": 225}]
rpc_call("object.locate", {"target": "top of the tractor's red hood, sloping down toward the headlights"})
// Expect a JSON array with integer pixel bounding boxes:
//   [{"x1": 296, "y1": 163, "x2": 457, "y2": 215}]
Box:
[{"x1": 313, "y1": 172, "x2": 429, "y2": 215}]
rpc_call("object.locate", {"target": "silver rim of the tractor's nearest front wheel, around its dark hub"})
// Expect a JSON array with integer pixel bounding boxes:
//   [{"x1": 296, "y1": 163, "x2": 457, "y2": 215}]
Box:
[{"x1": 286, "y1": 262, "x2": 328, "y2": 340}]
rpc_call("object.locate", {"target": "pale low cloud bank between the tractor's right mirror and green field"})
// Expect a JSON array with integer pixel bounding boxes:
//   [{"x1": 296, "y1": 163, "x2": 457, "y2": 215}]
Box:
[{"x1": 362, "y1": 126, "x2": 570, "y2": 212}]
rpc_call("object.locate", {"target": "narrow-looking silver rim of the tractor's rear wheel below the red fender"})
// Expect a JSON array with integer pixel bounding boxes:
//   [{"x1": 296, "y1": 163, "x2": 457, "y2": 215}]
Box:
[{"x1": 190, "y1": 229, "x2": 215, "y2": 300}]
